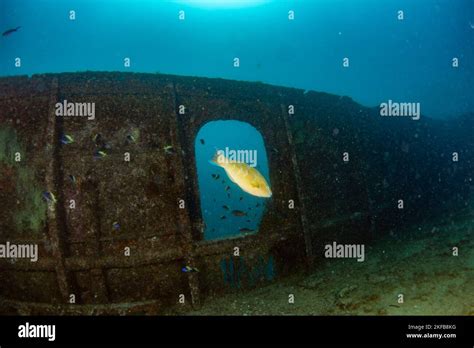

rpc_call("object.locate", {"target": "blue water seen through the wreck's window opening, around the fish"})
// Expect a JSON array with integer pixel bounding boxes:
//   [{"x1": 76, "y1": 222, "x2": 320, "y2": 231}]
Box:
[{"x1": 195, "y1": 121, "x2": 271, "y2": 240}]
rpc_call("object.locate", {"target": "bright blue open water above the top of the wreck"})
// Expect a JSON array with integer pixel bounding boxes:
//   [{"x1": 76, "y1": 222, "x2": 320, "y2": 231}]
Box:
[{"x1": 0, "y1": 0, "x2": 474, "y2": 117}]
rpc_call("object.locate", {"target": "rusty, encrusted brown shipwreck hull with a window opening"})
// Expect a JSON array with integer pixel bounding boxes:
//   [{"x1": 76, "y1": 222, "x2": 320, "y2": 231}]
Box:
[{"x1": 0, "y1": 73, "x2": 474, "y2": 314}]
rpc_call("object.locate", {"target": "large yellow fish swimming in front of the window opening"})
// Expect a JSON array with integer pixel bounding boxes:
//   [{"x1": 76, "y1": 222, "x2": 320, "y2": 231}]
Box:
[{"x1": 210, "y1": 153, "x2": 272, "y2": 198}]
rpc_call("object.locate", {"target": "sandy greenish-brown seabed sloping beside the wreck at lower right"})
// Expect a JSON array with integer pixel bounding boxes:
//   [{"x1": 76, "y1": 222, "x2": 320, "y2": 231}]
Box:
[{"x1": 182, "y1": 210, "x2": 474, "y2": 315}]
